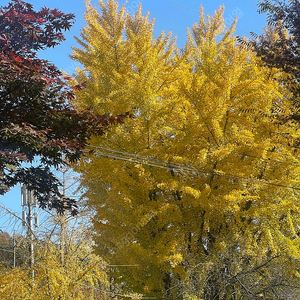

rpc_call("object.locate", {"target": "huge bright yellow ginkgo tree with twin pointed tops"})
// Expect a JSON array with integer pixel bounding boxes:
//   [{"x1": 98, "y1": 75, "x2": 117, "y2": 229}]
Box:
[{"x1": 72, "y1": 0, "x2": 300, "y2": 299}]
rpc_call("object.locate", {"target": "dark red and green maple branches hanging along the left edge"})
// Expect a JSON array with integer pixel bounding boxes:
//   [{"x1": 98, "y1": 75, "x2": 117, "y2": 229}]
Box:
[{"x1": 0, "y1": 0, "x2": 129, "y2": 213}]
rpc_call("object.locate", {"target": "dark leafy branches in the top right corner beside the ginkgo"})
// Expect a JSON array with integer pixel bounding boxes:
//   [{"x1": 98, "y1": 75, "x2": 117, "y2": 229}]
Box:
[{"x1": 250, "y1": 0, "x2": 300, "y2": 122}]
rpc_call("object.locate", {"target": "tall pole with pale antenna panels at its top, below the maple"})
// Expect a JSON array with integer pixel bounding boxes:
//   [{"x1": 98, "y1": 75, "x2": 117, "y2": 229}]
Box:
[{"x1": 21, "y1": 185, "x2": 38, "y2": 280}]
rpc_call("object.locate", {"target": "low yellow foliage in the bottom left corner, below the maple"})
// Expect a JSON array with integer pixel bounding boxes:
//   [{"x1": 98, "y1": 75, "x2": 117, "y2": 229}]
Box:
[{"x1": 0, "y1": 228, "x2": 110, "y2": 300}]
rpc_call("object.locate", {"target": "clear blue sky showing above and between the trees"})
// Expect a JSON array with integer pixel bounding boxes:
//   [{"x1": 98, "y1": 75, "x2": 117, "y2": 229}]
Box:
[{"x1": 0, "y1": 0, "x2": 266, "y2": 230}]
